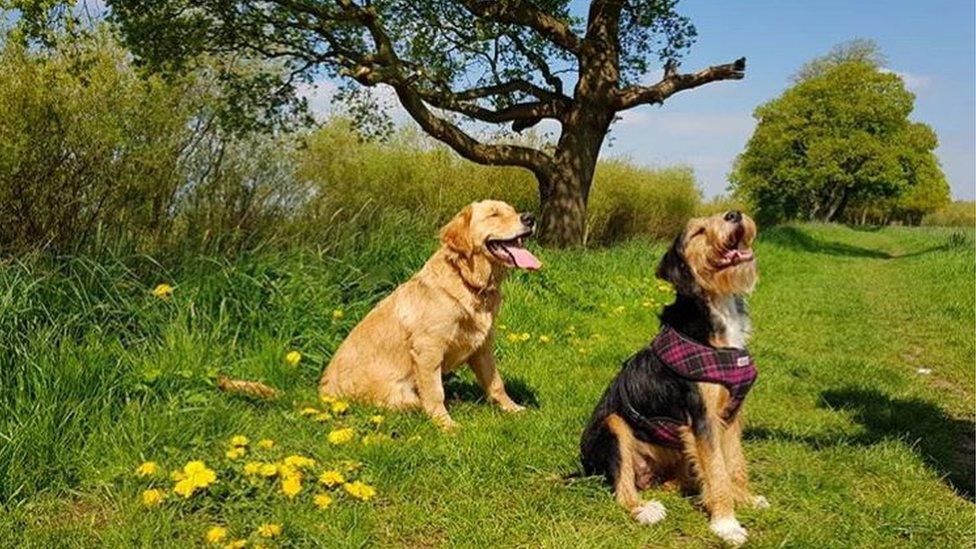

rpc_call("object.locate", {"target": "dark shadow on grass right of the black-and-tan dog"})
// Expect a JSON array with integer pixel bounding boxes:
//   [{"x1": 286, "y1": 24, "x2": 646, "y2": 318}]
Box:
[{"x1": 745, "y1": 388, "x2": 976, "y2": 501}]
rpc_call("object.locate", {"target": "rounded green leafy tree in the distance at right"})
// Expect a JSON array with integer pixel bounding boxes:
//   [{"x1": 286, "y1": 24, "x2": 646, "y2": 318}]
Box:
[{"x1": 730, "y1": 42, "x2": 948, "y2": 222}]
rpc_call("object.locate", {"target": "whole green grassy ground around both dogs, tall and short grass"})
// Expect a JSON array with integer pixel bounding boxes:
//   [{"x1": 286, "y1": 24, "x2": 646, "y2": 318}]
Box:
[{"x1": 0, "y1": 226, "x2": 976, "y2": 547}]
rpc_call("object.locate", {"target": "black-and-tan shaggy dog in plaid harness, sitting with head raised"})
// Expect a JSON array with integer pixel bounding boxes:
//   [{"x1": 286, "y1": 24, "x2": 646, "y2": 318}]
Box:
[{"x1": 580, "y1": 211, "x2": 769, "y2": 545}]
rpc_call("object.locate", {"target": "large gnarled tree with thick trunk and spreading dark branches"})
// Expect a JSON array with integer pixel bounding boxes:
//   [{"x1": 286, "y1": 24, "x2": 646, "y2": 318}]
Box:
[{"x1": 108, "y1": 0, "x2": 745, "y2": 245}]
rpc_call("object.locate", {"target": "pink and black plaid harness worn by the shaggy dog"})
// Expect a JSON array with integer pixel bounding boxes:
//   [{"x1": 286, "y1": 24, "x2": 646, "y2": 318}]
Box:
[{"x1": 633, "y1": 325, "x2": 758, "y2": 448}]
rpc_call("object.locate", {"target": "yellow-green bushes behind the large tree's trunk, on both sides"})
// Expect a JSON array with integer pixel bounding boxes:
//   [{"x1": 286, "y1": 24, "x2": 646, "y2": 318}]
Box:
[{"x1": 297, "y1": 124, "x2": 700, "y2": 244}]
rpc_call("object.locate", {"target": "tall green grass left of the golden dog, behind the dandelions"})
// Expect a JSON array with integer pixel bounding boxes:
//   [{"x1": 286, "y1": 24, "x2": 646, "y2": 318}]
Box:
[{"x1": 0, "y1": 220, "x2": 436, "y2": 504}]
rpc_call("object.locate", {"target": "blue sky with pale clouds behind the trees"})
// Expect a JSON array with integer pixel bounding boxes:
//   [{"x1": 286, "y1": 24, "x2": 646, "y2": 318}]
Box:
[{"x1": 302, "y1": 0, "x2": 976, "y2": 199}]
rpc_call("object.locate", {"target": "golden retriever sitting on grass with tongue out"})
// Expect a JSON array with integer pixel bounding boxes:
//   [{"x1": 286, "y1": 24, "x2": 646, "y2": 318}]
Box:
[{"x1": 319, "y1": 200, "x2": 541, "y2": 429}]
